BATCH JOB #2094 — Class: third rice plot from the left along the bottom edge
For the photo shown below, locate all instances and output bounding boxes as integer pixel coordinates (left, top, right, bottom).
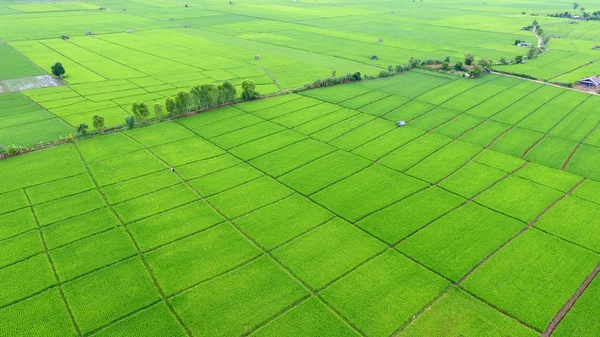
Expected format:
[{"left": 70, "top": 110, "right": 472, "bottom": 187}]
[{"left": 172, "top": 256, "right": 308, "bottom": 336}]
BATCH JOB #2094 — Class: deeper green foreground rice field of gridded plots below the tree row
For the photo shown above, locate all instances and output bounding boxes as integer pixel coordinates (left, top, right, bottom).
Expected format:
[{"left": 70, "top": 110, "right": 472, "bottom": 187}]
[{"left": 0, "top": 70, "right": 600, "bottom": 336}]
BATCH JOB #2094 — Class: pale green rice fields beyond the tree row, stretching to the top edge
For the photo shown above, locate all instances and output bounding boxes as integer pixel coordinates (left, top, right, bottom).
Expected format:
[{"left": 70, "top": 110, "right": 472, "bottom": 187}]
[{"left": 0, "top": 0, "right": 600, "bottom": 146}]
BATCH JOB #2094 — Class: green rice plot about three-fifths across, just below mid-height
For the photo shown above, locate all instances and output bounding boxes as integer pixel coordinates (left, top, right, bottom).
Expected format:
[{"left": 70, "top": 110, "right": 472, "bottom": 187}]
[{"left": 311, "top": 165, "right": 427, "bottom": 222}]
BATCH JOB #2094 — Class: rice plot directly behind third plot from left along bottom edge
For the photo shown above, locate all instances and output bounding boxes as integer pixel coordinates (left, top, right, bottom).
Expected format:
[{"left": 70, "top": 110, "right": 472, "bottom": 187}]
[{"left": 146, "top": 223, "right": 260, "bottom": 296}]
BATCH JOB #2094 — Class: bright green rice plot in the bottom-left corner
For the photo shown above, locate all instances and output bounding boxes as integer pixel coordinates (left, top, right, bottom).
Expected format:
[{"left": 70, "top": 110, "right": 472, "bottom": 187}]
[{"left": 0, "top": 288, "right": 77, "bottom": 337}]
